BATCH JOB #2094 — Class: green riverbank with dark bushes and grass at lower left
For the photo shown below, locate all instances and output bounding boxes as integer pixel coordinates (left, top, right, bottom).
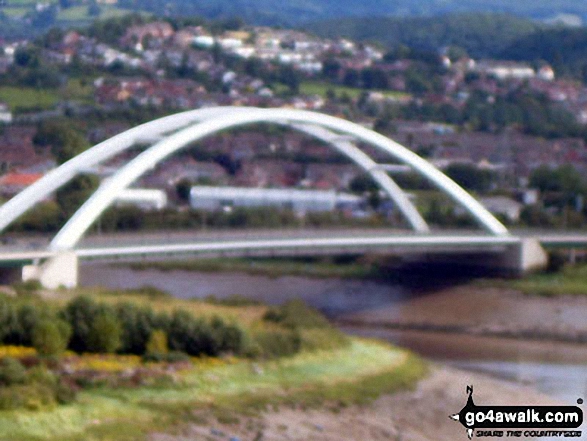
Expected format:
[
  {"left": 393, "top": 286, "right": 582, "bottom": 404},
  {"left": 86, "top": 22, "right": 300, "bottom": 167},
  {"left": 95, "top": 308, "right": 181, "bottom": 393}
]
[{"left": 0, "top": 286, "right": 426, "bottom": 440}]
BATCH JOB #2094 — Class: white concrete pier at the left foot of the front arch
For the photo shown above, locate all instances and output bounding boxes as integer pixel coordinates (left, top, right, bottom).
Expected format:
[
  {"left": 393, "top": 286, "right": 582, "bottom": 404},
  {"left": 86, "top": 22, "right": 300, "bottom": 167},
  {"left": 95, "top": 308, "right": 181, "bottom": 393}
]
[{"left": 22, "top": 251, "right": 78, "bottom": 289}]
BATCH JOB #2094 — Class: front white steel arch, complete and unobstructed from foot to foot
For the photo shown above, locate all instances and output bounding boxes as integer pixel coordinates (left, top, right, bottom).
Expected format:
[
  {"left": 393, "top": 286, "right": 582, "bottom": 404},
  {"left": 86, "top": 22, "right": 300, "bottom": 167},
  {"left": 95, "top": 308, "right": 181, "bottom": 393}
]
[{"left": 50, "top": 109, "right": 508, "bottom": 250}]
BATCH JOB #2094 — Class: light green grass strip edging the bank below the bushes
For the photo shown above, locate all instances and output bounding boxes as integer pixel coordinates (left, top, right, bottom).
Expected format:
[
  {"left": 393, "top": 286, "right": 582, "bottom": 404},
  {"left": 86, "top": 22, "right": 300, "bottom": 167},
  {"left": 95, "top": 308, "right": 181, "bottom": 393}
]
[{"left": 0, "top": 339, "right": 426, "bottom": 441}]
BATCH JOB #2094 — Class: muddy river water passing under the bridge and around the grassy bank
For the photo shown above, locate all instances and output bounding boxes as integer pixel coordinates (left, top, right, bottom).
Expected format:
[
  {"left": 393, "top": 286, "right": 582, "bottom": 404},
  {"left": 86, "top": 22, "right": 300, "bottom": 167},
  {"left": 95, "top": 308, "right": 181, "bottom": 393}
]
[{"left": 80, "top": 264, "right": 587, "bottom": 410}]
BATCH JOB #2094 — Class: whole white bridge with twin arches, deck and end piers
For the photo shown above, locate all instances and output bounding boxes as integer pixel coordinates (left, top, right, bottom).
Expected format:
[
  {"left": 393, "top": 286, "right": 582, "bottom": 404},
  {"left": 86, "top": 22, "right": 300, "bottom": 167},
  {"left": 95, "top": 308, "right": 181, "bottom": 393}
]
[{"left": 0, "top": 107, "right": 544, "bottom": 287}]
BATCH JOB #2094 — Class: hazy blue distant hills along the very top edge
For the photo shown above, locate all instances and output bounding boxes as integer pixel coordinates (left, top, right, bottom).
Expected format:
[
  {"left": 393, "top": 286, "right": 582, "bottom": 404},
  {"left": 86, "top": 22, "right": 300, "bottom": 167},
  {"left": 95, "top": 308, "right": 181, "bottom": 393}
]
[{"left": 0, "top": 0, "right": 587, "bottom": 40}]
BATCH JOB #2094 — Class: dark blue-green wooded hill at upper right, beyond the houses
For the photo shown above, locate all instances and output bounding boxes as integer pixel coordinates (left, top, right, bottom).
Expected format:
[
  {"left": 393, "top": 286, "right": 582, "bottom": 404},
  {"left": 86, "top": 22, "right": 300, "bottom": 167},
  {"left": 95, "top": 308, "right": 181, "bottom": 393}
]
[{"left": 304, "top": 14, "right": 587, "bottom": 81}]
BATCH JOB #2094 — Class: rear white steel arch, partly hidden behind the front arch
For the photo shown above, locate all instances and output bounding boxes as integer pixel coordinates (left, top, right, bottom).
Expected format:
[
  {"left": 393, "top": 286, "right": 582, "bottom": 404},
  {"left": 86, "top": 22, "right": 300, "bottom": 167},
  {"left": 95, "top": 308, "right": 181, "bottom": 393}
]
[{"left": 0, "top": 106, "right": 429, "bottom": 232}]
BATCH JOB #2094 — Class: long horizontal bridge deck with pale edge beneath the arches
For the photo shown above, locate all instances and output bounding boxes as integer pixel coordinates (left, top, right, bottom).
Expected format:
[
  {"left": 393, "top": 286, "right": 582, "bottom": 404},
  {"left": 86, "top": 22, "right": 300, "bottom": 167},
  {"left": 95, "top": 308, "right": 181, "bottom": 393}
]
[{"left": 0, "top": 229, "right": 587, "bottom": 264}]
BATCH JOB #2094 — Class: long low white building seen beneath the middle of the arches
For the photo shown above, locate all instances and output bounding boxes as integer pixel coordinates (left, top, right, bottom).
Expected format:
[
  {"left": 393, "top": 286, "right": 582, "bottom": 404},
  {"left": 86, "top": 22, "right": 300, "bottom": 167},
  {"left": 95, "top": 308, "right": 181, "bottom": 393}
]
[{"left": 190, "top": 186, "right": 363, "bottom": 212}]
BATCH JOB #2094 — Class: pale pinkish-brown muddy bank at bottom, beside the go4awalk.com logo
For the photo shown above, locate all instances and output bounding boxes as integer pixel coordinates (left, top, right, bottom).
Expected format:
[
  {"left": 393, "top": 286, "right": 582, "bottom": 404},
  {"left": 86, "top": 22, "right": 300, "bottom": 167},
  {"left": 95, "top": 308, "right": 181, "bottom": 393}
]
[{"left": 150, "top": 365, "right": 568, "bottom": 441}]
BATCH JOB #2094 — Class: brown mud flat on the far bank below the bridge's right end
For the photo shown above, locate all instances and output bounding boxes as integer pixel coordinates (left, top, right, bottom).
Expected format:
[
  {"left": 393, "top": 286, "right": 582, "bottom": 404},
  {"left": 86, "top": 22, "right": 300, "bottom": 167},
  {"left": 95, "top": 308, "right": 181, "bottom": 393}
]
[{"left": 336, "top": 285, "right": 587, "bottom": 343}]
